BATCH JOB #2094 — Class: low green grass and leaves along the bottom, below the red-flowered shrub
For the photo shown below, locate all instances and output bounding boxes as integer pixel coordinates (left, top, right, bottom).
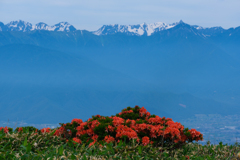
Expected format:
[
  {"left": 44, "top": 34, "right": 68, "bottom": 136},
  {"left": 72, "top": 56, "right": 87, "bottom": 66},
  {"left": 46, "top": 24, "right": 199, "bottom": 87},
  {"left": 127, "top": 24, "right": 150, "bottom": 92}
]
[{"left": 0, "top": 127, "right": 240, "bottom": 160}]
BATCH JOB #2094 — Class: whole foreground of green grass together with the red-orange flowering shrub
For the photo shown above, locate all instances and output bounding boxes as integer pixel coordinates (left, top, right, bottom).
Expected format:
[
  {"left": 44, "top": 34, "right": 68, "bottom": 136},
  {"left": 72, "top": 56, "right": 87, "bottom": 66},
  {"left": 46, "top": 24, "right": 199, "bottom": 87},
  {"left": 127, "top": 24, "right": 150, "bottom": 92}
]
[{"left": 0, "top": 106, "right": 240, "bottom": 160}]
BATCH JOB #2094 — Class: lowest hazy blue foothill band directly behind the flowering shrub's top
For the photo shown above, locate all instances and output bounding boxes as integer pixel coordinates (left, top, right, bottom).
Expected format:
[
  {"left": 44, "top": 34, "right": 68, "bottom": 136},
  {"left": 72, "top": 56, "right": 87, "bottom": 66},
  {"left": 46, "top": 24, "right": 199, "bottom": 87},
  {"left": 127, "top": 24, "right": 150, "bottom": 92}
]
[{"left": 0, "top": 85, "right": 239, "bottom": 124}]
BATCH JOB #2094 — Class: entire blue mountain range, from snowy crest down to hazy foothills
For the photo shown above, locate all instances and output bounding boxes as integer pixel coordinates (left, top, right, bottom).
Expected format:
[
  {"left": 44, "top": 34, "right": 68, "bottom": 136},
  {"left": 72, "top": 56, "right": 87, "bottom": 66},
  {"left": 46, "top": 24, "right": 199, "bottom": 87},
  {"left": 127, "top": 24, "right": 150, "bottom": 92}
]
[{"left": 0, "top": 21, "right": 240, "bottom": 123}]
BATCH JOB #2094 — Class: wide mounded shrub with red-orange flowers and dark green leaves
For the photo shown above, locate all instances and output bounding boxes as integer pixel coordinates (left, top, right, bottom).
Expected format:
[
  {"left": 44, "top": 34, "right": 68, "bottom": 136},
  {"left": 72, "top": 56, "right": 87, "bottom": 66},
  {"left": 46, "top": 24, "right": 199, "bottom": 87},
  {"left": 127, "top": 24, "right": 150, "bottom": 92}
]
[{"left": 54, "top": 106, "right": 203, "bottom": 147}]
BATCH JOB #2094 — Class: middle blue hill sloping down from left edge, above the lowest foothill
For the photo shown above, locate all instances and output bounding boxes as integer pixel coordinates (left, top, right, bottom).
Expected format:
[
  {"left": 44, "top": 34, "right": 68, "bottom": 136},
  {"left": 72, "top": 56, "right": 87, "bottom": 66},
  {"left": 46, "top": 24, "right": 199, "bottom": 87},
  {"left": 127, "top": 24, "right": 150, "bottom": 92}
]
[{"left": 0, "top": 44, "right": 150, "bottom": 89}]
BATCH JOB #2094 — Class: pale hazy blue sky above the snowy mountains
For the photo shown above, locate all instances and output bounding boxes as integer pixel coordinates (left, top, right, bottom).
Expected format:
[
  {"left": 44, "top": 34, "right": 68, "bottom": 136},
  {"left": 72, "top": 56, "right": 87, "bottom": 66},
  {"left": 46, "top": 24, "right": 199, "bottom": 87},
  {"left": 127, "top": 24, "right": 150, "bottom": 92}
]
[{"left": 0, "top": 0, "right": 240, "bottom": 31}]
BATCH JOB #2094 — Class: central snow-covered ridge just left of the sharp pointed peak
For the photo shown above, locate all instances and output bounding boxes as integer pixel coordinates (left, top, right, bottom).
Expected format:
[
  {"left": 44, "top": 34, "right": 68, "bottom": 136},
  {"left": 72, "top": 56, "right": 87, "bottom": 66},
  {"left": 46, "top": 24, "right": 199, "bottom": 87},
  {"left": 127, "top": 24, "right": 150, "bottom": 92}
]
[{"left": 93, "top": 22, "right": 178, "bottom": 36}]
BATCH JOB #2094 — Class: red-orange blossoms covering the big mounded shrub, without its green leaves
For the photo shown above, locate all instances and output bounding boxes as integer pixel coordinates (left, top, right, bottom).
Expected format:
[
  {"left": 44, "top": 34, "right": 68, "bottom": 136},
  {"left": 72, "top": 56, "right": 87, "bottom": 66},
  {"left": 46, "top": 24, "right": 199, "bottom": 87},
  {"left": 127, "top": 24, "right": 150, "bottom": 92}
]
[{"left": 54, "top": 107, "right": 203, "bottom": 146}]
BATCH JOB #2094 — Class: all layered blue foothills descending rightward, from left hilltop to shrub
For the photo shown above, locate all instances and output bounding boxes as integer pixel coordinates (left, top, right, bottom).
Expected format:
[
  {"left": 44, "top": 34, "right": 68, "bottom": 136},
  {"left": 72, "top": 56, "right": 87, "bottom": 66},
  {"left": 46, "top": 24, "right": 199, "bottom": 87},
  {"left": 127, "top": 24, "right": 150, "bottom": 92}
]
[{"left": 0, "top": 44, "right": 237, "bottom": 123}]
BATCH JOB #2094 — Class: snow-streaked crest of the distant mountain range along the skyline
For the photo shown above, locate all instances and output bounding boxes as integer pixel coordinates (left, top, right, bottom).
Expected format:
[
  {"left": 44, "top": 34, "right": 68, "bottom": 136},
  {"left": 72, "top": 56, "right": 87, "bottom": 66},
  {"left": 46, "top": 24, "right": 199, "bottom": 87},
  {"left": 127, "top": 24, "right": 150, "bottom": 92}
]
[{"left": 0, "top": 20, "right": 235, "bottom": 37}]
